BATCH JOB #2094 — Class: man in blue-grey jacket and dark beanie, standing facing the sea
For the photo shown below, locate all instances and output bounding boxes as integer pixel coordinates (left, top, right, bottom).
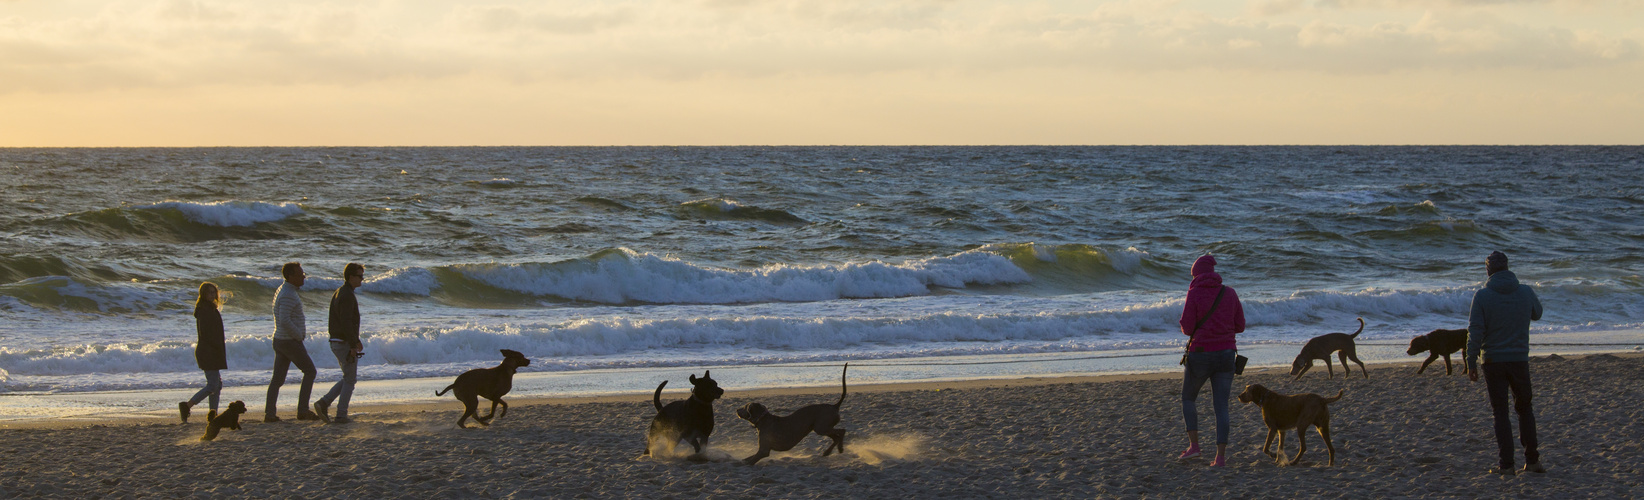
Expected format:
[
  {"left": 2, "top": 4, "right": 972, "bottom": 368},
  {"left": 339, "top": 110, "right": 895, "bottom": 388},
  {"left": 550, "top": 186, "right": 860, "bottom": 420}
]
[{"left": 1466, "top": 252, "right": 1547, "bottom": 475}]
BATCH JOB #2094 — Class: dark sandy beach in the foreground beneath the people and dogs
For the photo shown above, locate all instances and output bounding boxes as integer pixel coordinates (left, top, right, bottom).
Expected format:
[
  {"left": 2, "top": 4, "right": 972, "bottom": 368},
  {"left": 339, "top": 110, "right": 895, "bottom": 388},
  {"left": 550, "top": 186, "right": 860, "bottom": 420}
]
[{"left": 0, "top": 355, "right": 1644, "bottom": 498}]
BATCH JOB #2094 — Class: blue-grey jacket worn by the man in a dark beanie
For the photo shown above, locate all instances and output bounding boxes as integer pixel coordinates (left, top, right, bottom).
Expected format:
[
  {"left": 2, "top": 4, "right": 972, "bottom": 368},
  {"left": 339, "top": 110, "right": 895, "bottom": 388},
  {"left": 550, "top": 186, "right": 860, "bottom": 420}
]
[{"left": 1466, "top": 270, "right": 1542, "bottom": 370}]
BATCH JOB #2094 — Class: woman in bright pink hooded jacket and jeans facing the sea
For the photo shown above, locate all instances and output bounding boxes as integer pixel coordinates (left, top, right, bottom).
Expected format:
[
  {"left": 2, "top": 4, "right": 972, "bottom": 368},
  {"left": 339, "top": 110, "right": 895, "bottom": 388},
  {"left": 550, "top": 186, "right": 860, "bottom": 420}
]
[{"left": 1182, "top": 255, "right": 1245, "bottom": 467}]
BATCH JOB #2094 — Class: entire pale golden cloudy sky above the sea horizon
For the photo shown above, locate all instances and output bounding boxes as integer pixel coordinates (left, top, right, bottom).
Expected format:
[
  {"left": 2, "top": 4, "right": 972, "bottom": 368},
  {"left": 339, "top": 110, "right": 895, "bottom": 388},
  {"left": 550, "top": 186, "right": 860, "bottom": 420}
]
[{"left": 0, "top": 0, "right": 1644, "bottom": 146}]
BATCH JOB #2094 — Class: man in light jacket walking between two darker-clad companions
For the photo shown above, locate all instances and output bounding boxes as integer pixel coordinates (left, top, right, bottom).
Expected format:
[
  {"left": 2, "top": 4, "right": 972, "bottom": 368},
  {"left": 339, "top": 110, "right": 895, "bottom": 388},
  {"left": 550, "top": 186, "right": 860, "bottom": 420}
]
[{"left": 263, "top": 262, "right": 319, "bottom": 423}]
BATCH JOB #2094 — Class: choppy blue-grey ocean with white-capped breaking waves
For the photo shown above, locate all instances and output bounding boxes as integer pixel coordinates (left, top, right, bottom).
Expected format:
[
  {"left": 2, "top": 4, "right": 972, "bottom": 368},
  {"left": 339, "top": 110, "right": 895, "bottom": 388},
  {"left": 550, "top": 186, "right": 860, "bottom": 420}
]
[{"left": 0, "top": 146, "right": 1644, "bottom": 398}]
